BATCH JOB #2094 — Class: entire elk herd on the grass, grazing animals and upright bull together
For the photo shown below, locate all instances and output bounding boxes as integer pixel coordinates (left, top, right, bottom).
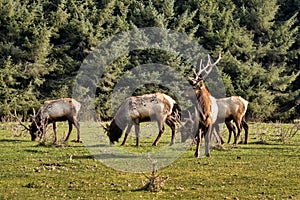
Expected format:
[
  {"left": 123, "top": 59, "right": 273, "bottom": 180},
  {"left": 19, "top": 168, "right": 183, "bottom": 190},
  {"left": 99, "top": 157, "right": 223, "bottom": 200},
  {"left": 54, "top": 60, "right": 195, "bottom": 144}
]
[{"left": 15, "top": 54, "right": 253, "bottom": 158}]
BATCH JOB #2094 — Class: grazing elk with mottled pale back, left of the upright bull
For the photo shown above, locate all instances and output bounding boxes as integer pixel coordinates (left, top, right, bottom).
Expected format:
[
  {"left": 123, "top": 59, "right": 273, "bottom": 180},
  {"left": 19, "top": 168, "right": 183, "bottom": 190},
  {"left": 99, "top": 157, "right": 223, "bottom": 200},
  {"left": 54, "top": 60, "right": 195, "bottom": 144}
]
[{"left": 101, "top": 93, "right": 176, "bottom": 146}]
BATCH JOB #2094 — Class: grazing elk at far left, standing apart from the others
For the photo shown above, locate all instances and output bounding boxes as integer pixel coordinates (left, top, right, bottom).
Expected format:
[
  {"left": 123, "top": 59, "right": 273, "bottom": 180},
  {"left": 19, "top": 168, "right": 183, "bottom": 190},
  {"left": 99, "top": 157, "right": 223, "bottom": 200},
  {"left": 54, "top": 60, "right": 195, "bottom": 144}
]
[{"left": 21, "top": 98, "right": 81, "bottom": 143}]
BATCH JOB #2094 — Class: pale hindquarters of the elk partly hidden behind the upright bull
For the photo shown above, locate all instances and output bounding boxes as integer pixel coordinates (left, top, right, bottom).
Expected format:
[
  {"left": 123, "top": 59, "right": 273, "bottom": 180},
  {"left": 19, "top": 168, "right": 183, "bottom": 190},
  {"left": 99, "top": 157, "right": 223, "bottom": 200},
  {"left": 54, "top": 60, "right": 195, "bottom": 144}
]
[{"left": 215, "top": 96, "right": 249, "bottom": 146}]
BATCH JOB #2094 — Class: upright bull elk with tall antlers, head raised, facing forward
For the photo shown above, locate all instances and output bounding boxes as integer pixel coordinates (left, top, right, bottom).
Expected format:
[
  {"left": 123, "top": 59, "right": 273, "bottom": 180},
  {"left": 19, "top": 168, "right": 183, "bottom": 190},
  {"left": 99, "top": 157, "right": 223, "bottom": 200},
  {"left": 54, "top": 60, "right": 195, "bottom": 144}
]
[{"left": 182, "top": 53, "right": 221, "bottom": 158}]
